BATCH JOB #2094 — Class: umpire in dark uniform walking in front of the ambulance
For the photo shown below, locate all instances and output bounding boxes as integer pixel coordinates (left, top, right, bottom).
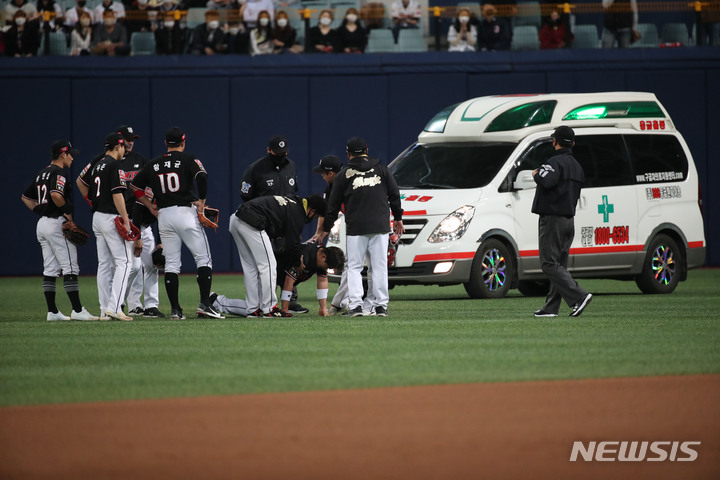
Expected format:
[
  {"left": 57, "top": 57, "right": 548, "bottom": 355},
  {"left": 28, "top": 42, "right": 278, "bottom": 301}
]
[{"left": 532, "top": 125, "right": 592, "bottom": 317}]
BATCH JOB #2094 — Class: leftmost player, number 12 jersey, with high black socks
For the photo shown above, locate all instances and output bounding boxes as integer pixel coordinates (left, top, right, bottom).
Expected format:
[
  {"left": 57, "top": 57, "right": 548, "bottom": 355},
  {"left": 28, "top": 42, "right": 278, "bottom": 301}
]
[{"left": 22, "top": 140, "right": 98, "bottom": 322}]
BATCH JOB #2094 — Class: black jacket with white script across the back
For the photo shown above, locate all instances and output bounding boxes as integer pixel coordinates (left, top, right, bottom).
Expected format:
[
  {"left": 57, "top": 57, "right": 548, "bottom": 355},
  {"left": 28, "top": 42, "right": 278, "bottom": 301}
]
[{"left": 323, "top": 156, "right": 403, "bottom": 235}]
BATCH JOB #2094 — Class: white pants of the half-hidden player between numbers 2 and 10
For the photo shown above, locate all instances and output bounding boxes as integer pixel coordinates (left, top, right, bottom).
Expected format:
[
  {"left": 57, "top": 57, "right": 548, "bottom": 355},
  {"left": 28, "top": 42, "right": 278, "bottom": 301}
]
[{"left": 127, "top": 226, "right": 160, "bottom": 311}]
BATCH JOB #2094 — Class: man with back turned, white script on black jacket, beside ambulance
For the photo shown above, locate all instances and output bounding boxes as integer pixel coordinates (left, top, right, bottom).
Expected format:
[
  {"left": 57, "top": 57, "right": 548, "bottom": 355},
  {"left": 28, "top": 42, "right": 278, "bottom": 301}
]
[{"left": 323, "top": 137, "right": 405, "bottom": 317}]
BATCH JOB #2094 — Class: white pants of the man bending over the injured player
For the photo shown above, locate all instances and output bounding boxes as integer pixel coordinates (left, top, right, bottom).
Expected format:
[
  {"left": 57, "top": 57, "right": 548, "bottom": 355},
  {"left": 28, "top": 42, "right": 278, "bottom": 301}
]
[{"left": 230, "top": 215, "right": 277, "bottom": 313}]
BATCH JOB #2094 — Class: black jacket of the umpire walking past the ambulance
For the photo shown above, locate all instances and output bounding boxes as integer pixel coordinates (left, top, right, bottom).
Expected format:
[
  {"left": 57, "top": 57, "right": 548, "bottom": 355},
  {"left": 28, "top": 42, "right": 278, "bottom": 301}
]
[{"left": 532, "top": 148, "right": 585, "bottom": 217}]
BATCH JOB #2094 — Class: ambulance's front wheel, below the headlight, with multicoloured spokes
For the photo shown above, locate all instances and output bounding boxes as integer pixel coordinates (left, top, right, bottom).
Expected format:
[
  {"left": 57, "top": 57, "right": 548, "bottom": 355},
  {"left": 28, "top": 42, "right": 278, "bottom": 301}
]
[{"left": 463, "top": 238, "right": 517, "bottom": 298}]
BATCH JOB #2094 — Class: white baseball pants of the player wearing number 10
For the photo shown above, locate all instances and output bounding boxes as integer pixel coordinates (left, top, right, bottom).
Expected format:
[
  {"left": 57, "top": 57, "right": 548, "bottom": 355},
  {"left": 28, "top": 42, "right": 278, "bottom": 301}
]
[{"left": 158, "top": 206, "right": 212, "bottom": 273}]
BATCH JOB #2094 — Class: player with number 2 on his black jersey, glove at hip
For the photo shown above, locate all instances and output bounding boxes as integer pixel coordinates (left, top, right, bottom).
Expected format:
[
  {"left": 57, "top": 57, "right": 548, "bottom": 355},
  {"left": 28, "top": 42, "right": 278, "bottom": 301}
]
[{"left": 77, "top": 132, "right": 133, "bottom": 321}]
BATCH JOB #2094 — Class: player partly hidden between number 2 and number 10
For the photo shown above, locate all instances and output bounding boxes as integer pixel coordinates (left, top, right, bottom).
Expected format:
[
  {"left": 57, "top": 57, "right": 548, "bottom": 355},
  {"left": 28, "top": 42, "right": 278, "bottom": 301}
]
[{"left": 115, "top": 125, "right": 165, "bottom": 318}]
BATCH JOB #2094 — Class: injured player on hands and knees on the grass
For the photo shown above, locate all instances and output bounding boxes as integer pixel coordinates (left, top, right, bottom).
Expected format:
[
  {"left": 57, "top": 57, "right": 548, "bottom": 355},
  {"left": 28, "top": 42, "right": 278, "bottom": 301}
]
[{"left": 210, "top": 243, "right": 345, "bottom": 318}]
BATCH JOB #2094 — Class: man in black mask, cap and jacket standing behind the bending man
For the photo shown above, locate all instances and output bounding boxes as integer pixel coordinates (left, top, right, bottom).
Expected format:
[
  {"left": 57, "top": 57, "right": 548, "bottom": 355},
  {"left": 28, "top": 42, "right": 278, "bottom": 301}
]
[{"left": 240, "top": 135, "right": 309, "bottom": 313}]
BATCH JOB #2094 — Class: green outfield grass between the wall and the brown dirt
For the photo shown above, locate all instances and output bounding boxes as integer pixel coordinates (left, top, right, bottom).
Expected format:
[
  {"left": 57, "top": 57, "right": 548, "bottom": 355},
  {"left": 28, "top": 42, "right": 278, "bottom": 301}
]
[{"left": 0, "top": 269, "right": 720, "bottom": 405}]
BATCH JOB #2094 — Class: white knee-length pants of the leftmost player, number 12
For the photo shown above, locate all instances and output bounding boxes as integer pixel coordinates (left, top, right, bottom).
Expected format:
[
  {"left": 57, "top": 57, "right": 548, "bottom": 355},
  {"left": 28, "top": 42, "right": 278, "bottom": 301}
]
[{"left": 35, "top": 217, "right": 80, "bottom": 277}]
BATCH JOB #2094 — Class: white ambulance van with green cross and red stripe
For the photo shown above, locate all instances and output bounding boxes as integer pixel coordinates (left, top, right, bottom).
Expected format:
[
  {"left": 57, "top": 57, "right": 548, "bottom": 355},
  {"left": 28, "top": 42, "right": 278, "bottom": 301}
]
[{"left": 329, "top": 92, "right": 706, "bottom": 298}]
